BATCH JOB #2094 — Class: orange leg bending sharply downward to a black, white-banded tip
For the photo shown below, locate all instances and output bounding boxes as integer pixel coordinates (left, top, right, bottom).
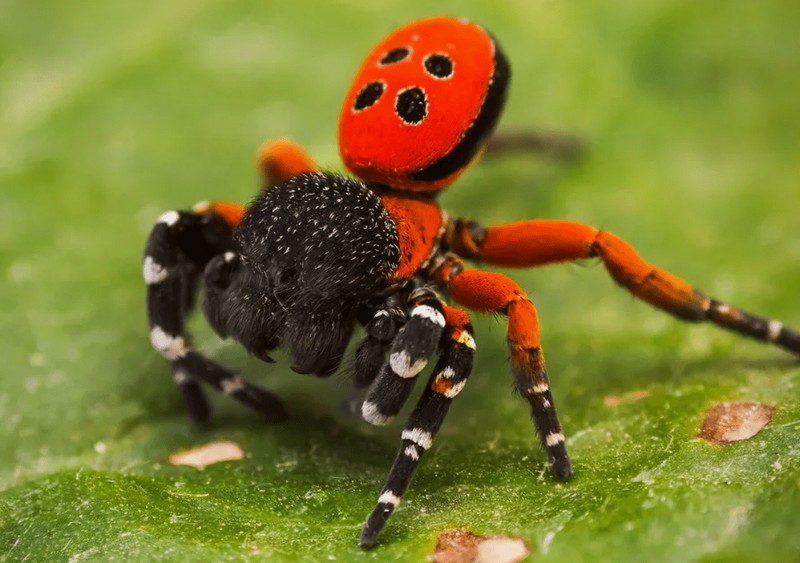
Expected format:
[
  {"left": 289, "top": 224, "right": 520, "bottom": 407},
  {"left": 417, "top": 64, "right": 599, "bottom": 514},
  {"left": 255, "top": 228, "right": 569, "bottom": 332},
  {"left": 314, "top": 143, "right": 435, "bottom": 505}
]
[{"left": 436, "top": 260, "right": 572, "bottom": 481}]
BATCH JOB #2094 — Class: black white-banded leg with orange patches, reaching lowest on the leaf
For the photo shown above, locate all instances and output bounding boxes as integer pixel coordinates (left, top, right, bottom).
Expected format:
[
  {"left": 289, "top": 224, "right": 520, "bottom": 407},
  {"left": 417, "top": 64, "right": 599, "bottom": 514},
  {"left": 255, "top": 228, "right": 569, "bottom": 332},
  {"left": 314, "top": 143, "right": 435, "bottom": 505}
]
[{"left": 360, "top": 305, "right": 475, "bottom": 549}]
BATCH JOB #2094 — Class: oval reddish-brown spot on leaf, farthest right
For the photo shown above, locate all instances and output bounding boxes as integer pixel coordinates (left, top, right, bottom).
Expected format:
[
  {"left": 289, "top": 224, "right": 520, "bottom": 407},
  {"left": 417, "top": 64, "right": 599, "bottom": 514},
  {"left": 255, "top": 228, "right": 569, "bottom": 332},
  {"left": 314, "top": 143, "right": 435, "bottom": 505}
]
[{"left": 698, "top": 401, "right": 775, "bottom": 444}]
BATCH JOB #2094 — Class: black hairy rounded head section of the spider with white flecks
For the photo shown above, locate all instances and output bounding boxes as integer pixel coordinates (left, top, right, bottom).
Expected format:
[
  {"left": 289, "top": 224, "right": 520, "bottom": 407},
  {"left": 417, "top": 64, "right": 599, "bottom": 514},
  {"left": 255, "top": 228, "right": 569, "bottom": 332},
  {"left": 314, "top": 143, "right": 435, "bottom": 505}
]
[{"left": 211, "top": 173, "right": 400, "bottom": 375}]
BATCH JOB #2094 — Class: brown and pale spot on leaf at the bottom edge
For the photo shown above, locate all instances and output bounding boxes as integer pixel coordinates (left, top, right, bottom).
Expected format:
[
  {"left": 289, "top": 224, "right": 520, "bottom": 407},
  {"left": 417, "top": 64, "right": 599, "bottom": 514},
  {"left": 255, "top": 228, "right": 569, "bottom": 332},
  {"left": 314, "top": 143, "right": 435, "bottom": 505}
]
[{"left": 428, "top": 529, "right": 530, "bottom": 563}]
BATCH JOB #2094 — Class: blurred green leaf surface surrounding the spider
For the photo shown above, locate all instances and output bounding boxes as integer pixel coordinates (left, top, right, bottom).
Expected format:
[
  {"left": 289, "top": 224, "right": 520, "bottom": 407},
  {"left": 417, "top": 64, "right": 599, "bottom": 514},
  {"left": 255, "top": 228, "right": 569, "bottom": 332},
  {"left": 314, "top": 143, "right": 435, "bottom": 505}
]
[{"left": 0, "top": 0, "right": 800, "bottom": 561}]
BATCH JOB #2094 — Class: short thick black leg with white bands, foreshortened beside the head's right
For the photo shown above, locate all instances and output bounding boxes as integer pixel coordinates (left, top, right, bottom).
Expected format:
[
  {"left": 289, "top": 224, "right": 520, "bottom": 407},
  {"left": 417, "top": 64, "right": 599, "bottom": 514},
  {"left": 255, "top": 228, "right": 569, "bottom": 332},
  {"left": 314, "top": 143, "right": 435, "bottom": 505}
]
[{"left": 361, "top": 287, "right": 445, "bottom": 424}]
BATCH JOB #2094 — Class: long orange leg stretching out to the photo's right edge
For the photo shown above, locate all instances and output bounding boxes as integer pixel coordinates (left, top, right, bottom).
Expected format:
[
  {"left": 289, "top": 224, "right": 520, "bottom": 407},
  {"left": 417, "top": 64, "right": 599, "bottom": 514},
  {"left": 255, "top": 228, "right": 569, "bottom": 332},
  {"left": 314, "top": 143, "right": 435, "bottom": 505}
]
[{"left": 450, "top": 220, "right": 800, "bottom": 355}]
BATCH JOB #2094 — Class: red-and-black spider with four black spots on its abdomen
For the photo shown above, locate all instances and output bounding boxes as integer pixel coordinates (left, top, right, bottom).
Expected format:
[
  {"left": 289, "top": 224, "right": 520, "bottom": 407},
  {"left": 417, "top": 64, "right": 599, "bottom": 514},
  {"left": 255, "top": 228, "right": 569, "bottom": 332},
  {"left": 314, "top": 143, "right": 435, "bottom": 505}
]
[{"left": 144, "top": 17, "right": 800, "bottom": 548}]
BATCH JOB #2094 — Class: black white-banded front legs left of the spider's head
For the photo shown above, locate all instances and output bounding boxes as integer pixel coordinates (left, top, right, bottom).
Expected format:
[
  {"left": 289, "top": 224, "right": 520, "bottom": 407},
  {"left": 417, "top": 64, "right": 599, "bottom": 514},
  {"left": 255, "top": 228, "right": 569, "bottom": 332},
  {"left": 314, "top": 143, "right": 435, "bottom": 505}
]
[{"left": 143, "top": 211, "right": 283, "bottom": 422}]
